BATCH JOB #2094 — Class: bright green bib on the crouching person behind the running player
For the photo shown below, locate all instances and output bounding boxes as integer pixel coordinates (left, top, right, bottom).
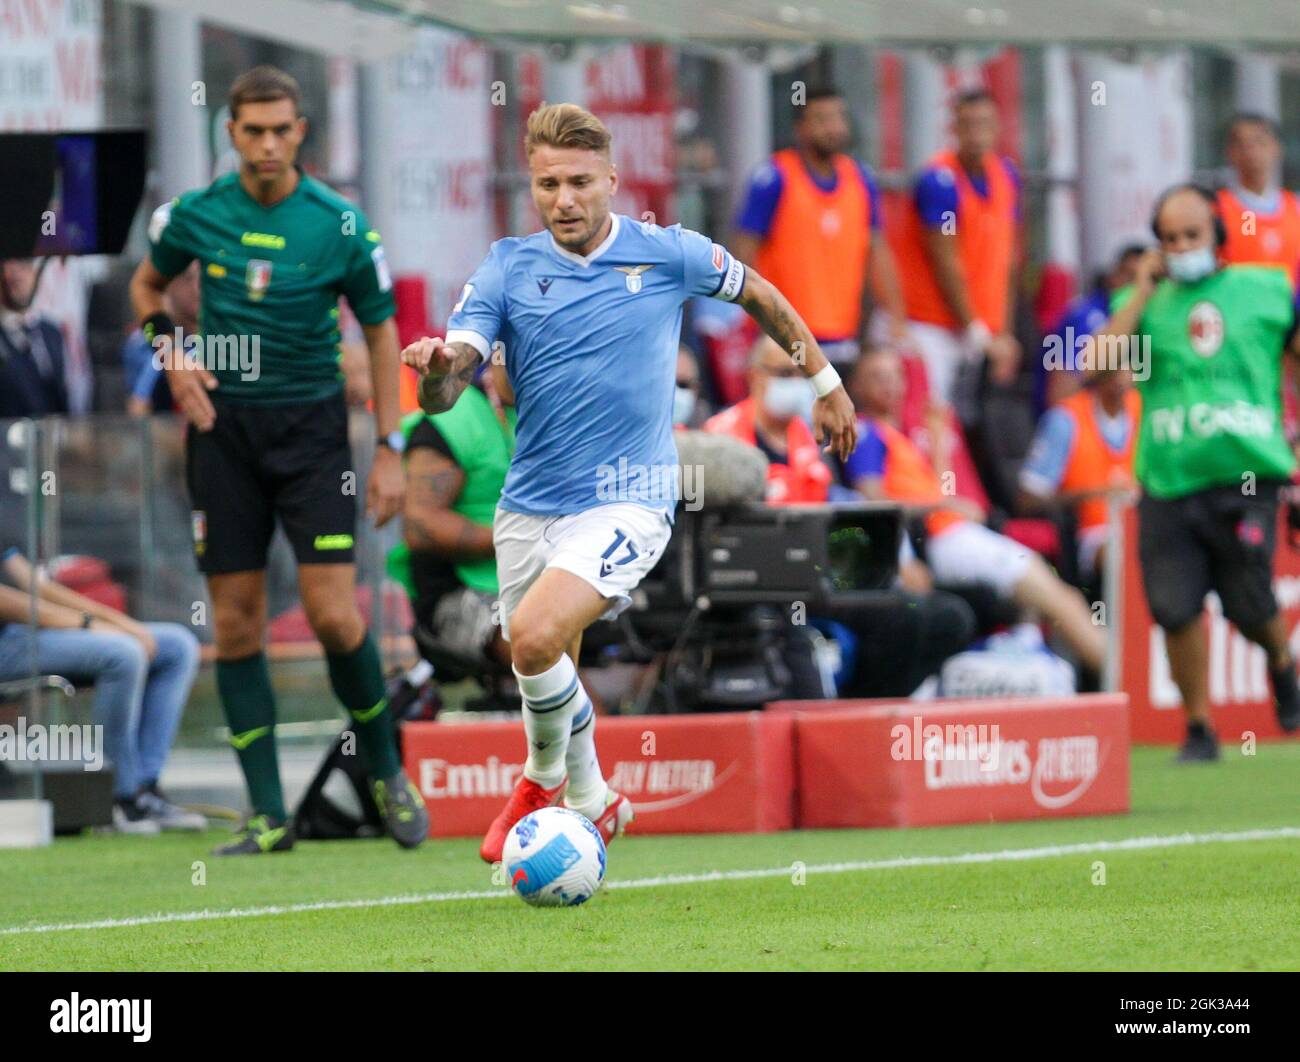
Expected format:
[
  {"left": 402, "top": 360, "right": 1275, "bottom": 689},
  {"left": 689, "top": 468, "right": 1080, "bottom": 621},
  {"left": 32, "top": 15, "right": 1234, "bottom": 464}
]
[{"left": 387, "top": 387, "right": 515, "bottom": 601}]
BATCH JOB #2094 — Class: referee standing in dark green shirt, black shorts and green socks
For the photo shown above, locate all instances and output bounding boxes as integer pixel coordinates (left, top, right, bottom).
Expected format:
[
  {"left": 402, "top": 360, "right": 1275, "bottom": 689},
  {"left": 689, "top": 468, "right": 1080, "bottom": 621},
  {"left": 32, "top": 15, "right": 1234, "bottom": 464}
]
[{"left": 131, "top": 66, "right": 429, "bottom": 855}]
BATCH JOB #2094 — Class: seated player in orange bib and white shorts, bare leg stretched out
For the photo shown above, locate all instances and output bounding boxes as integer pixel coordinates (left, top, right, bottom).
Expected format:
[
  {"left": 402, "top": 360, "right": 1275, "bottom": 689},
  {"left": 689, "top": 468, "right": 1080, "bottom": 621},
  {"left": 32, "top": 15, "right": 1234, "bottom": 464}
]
[{"left": 845, "top": 348, "right": 1105, "bottom": 671}]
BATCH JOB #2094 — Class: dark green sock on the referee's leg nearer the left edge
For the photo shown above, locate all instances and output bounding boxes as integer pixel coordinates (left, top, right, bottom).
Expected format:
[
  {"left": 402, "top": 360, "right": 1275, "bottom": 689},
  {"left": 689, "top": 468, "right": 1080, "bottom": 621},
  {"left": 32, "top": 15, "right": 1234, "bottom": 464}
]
[{"left": 217, "top": 653, "right": 289, "bottom": 822}]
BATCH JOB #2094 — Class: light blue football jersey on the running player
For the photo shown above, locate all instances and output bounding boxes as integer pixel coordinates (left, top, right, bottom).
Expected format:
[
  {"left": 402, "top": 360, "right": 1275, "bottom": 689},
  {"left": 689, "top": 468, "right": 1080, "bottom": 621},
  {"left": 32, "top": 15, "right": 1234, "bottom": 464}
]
[{"left": 447, "top": 214, "right": 745, "bottom": 516}]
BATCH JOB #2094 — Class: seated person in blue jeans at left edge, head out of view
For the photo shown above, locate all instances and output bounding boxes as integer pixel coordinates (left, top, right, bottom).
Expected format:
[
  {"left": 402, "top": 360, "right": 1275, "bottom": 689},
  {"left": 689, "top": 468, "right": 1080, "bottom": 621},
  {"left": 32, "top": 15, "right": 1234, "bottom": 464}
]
[{"left": 0, "top": 546, "right": 207, "bottom": 833}]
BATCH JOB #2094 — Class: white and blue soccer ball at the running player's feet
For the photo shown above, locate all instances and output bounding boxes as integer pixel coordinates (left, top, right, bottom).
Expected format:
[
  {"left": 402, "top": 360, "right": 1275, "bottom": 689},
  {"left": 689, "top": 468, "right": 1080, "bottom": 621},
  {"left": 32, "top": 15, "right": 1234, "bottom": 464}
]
[{"left": 501, "top": 807, "right": 605, "bottom": 907}]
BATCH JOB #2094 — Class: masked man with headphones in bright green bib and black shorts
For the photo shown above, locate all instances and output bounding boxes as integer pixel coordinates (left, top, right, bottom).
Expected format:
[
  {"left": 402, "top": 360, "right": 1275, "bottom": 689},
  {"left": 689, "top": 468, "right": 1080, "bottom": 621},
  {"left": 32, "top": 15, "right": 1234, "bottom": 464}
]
[{"left": 1101, "top": 185, "right": 1300, "bottom": 762}]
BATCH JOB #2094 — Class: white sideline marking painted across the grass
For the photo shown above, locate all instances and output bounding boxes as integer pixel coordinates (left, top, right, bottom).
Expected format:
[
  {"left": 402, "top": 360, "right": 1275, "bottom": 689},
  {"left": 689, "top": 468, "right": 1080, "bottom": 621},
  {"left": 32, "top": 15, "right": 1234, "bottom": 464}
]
[{"left": 0, "top": 825, "right": 1300, "bottom": 936}]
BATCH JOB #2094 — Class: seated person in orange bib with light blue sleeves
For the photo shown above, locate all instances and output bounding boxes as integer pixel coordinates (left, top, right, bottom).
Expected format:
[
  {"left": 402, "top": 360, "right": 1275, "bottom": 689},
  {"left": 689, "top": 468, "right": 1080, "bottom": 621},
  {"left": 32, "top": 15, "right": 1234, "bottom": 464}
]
[{"left": 1021, "top": 369, "right": 1141, "bottom": 588}]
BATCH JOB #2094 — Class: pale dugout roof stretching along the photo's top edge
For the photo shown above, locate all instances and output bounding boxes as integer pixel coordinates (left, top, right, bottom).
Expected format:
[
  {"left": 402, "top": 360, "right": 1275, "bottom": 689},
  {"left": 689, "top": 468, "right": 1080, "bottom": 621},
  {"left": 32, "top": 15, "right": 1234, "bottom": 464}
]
[{"left": 129, "top": 0, "right": 1300, "bottom": 60}]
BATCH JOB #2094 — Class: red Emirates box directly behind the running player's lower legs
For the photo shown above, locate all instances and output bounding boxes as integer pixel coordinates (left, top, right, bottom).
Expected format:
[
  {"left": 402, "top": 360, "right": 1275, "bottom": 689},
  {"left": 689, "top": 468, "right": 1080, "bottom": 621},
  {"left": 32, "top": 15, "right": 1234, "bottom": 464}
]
[{"left": 402, "top": 712, "right": 794, "bottom": 837}]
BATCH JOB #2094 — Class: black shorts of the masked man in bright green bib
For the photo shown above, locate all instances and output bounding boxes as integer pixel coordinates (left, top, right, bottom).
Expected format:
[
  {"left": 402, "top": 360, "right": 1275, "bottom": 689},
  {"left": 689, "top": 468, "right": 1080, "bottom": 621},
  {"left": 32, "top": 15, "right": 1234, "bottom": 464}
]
[{"left": 1138, "top": 480, "right": 1282, "bottom": 632}]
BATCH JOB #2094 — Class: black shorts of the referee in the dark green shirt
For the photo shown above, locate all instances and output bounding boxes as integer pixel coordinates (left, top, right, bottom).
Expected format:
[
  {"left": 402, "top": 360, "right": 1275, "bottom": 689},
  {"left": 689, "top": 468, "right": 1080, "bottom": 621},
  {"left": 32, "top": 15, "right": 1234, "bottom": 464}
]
[{"left": 186, "top": 394, "right": 358, "bottom": 575}]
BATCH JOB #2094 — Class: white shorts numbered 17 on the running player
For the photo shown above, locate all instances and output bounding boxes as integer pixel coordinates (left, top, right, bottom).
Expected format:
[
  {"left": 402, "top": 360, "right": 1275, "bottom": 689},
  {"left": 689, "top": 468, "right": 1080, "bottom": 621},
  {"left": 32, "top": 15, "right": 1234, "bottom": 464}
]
[{"left": 491, "top": 502, "right": 672, "bottom": 641}]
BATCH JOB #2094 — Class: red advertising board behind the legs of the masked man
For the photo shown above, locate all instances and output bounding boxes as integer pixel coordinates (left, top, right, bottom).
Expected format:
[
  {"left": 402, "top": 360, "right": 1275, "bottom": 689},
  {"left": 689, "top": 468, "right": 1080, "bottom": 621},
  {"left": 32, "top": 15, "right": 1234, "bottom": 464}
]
[{"left": 1119, "top": 510, "right": 1300, "bottom": 744}]
